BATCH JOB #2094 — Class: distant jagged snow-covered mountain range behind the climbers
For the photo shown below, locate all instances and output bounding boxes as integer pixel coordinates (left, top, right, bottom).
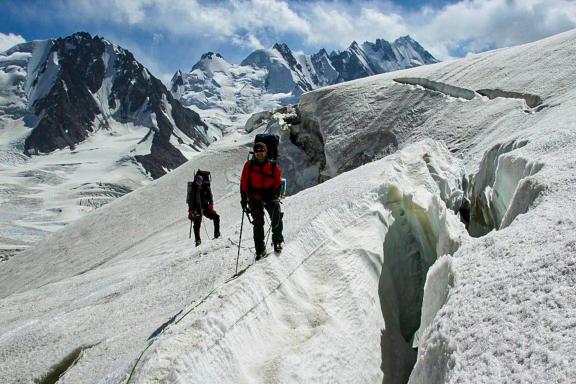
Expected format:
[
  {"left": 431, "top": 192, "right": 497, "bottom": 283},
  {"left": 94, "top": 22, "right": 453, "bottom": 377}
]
[{"left": 171, "top": 36, "right": 437, "bottom": 125}]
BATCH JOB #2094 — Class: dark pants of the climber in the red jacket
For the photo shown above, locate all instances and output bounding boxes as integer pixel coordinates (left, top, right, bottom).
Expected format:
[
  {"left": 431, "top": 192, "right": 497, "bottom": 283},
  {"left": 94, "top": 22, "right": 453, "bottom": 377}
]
[{"left": 248, "top": 198, "right": 284, "bottom": 254}]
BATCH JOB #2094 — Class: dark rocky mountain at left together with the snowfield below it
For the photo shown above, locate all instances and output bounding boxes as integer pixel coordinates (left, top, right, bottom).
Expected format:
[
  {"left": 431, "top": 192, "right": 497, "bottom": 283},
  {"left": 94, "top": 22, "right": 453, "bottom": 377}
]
[{"left": 0, "top": 33, "right": 214, "bottom": 256}]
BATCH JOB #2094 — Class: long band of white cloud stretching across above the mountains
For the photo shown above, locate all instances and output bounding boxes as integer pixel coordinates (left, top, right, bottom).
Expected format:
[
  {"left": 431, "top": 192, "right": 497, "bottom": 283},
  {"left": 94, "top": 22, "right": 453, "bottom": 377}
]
[{"left": 12, "top": 0, "right": 576, "bottom": 59}]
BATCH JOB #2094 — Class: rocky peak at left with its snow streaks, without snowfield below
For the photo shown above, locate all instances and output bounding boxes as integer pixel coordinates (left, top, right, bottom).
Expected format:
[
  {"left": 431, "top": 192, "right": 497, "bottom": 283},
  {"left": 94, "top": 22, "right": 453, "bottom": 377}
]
[{"left": 0, "top": 32, "right": 214, "bottom": 178}]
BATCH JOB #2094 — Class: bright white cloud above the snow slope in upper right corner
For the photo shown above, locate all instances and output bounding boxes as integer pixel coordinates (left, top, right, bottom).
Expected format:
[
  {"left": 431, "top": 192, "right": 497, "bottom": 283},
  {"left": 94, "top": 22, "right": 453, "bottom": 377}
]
[{"left": 411, "top": 0, "right": 576, "bottom": 58}]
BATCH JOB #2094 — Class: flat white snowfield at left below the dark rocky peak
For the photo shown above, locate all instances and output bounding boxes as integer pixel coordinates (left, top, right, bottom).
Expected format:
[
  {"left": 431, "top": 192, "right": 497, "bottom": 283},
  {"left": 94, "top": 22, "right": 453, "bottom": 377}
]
[{"left": 0, "top": 117, "right": 155, "bottom": 255}]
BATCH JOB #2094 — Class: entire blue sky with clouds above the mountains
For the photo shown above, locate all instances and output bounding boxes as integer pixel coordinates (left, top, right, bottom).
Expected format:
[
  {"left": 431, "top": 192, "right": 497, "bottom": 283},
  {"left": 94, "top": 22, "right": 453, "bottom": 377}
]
[{"left": 0, "top": 0, "right": 576, "bottom": 81}]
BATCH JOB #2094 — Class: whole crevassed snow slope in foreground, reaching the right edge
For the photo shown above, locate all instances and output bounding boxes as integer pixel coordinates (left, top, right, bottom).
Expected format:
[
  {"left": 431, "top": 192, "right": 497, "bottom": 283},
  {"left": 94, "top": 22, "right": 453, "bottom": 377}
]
[{"left": 0, "top": 27, "right": 576, "bottom": 383}]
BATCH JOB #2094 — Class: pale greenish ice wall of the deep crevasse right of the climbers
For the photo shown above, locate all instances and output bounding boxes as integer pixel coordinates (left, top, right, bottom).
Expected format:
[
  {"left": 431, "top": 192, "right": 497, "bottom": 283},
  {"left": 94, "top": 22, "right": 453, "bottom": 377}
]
[{"left": 378, "top": 141, "right": 466, "bottom": 384}]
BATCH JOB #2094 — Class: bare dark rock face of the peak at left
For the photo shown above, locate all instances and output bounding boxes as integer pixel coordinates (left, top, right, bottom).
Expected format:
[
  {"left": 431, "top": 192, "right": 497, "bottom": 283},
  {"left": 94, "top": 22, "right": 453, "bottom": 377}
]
[{"left": 25, "top": 33, "right": 209, "bottom": 178}]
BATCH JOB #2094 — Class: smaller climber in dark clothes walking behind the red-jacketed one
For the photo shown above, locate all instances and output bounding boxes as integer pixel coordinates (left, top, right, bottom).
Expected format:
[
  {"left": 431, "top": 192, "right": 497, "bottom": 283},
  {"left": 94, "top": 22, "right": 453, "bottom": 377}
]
[{"left": 187, "top": 175, "right": 220, "bottom": 246}]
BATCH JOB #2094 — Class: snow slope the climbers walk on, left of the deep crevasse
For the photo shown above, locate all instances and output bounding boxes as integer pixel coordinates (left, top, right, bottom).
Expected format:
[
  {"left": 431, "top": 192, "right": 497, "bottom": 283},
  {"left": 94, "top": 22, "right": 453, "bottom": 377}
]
[{"left": 1, "top": 133, "right": 458, "bottom": 383}]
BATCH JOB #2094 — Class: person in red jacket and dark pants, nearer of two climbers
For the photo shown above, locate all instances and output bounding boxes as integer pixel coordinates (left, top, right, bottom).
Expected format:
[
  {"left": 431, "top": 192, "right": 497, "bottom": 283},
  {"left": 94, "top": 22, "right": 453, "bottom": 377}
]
[{"left": 240, "top": 143, "right": 284, "bottom": 260}]
